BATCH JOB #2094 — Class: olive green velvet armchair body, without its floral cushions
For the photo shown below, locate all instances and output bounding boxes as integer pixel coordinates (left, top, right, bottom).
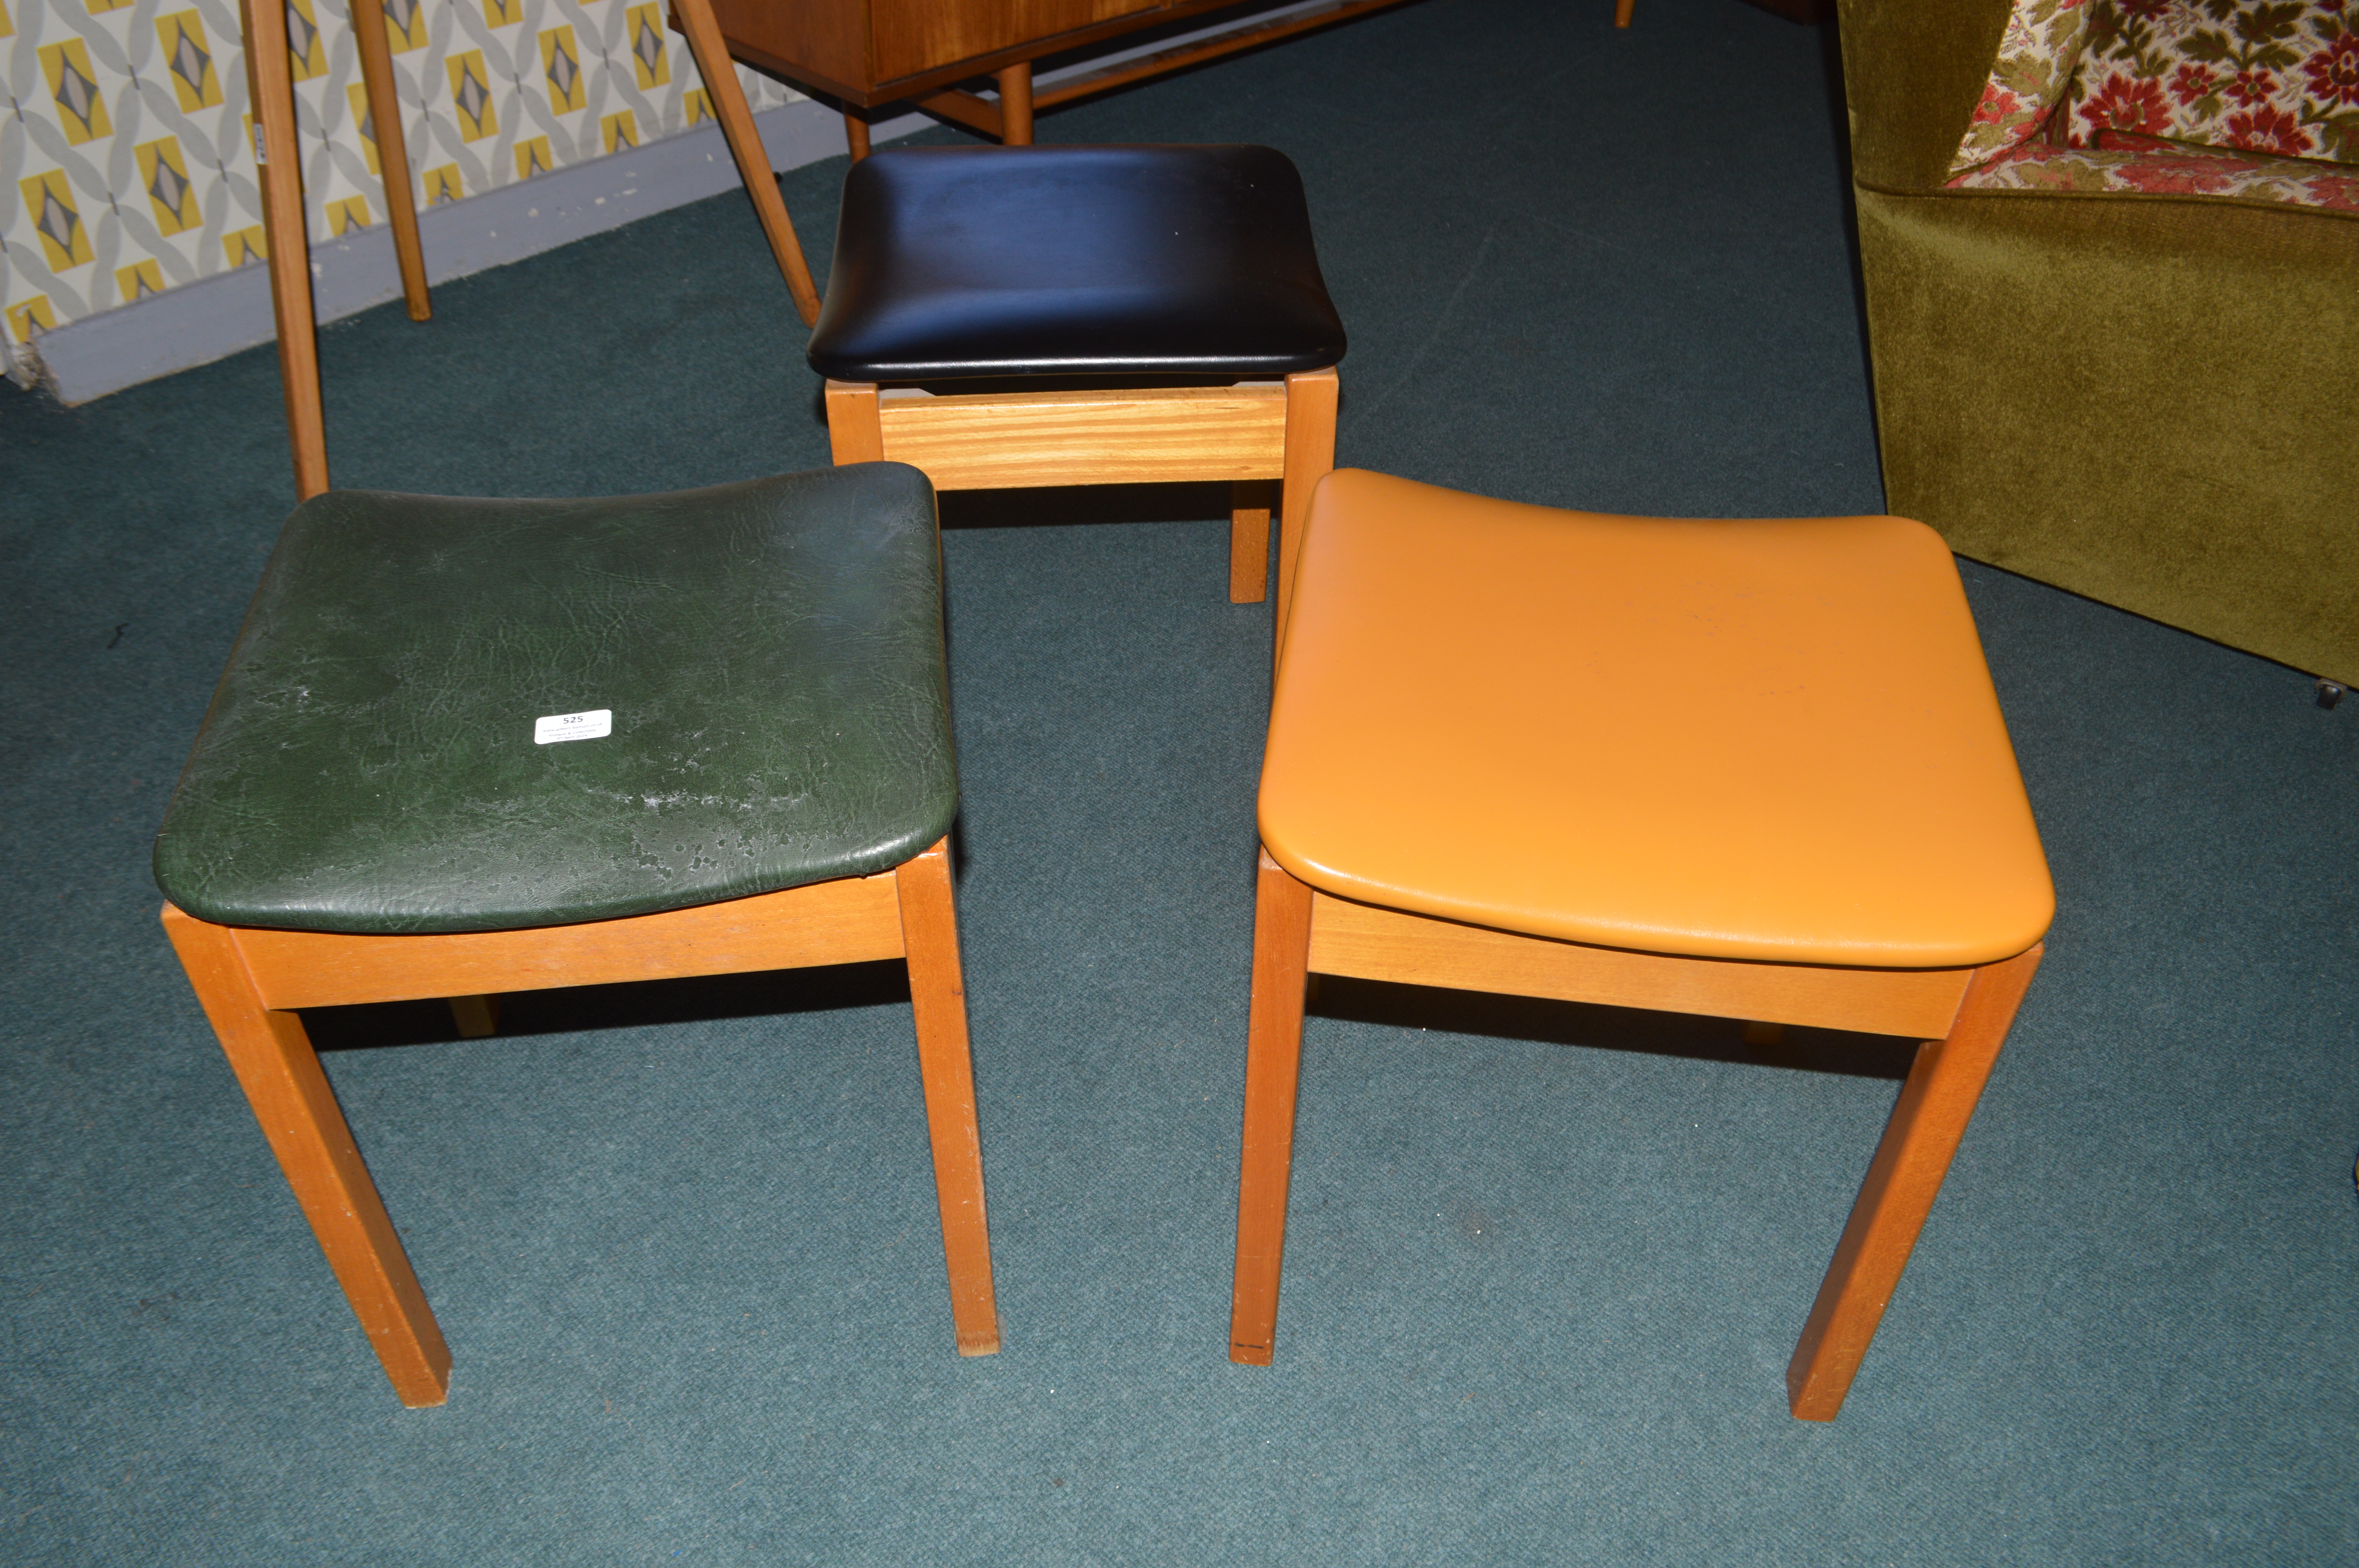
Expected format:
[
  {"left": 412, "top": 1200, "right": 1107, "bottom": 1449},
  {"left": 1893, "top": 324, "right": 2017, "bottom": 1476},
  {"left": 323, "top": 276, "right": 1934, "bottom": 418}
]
[{"left": 1840, "top": 0, "right": 2359, "bottom": 681}]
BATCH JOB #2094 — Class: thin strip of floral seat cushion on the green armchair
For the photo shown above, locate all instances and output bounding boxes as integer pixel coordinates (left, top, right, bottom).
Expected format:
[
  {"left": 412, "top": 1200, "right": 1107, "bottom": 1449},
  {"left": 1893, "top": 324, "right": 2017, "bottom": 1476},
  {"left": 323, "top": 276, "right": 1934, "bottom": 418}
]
[{"left": 1948, "top": 130, "right": 2359, "bottom": 214}]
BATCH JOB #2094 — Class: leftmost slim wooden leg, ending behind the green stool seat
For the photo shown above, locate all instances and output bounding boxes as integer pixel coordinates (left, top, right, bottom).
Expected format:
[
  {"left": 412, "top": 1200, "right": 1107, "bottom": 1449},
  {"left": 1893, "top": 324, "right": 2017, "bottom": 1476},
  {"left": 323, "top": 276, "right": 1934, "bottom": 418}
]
[{"left": 238, "top": 0, "right": 328, "bottom": 500}]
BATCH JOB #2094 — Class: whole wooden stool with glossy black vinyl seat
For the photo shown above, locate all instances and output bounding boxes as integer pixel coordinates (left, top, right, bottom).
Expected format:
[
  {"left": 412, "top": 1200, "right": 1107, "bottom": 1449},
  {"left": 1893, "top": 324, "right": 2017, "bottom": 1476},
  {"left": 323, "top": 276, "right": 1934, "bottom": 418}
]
[{"left": 812, "top": 146, "right": 1345, "bottom": 620}]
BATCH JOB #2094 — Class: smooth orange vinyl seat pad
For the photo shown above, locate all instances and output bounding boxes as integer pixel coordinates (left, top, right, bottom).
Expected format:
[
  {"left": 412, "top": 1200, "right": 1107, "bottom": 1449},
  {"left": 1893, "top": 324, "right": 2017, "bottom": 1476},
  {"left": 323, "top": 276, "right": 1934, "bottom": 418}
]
[{"left": 1260, "top": 469, "right": 2055, "bottom": 969}]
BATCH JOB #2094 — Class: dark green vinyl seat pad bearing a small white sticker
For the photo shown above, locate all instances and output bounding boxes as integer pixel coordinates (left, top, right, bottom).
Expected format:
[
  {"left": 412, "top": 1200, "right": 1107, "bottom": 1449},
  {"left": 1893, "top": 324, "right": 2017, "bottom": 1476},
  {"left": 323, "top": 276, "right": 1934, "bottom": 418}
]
[{"left": 156, "top": 462, "right": 958, "bottom": 934}]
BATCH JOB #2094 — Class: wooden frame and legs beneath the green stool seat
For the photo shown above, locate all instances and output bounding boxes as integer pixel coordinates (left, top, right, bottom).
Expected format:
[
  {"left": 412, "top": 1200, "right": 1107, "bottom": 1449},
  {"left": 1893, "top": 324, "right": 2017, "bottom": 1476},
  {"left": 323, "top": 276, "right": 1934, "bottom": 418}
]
[{"left": 163, "top": 839, "right": 1000, "bottom": 1408}]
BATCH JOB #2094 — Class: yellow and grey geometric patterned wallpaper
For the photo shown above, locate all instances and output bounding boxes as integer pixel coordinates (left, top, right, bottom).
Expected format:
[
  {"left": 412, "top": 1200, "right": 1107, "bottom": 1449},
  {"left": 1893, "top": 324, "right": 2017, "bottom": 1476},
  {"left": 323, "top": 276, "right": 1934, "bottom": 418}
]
[{"left": 0, "top": 0, "right": 800, "bottom": 342}]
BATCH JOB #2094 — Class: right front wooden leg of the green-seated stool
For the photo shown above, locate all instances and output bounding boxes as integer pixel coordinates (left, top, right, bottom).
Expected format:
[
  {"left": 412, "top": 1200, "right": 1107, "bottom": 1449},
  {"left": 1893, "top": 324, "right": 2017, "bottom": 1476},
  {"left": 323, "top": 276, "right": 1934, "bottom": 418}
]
[{"left": 894, "top": 839, "right": 1000, "bottom": 1356}]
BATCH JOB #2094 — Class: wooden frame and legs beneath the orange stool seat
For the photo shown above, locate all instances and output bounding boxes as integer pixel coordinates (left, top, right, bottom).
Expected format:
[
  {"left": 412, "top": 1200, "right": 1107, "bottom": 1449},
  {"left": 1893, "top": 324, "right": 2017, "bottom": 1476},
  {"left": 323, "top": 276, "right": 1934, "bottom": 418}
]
[{"left": 1229, "top": 849, "right": 2043, "bottom": 1422}]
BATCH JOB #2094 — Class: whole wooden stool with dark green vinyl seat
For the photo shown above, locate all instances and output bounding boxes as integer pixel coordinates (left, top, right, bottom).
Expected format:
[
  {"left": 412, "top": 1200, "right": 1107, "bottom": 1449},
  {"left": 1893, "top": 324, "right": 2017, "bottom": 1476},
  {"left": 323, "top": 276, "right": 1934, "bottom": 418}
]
[{"left": 156, "top": 462, "right": 1000, "bottom": 1405}]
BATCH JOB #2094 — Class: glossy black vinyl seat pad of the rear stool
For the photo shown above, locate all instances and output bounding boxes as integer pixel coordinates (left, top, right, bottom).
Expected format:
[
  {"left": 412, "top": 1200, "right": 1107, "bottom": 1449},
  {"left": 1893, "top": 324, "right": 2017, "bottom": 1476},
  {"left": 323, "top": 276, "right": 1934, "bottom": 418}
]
[{"left": 809, "top": 146, "right": 1345, "bottom": 382}]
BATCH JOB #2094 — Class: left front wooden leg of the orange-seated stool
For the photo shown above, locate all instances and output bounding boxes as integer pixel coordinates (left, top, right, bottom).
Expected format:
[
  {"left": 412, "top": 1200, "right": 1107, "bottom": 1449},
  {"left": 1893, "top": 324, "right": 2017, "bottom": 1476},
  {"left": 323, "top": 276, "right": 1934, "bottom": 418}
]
[{"left": 1229, "top": 849, "right": 1312, "bottom": 1368}]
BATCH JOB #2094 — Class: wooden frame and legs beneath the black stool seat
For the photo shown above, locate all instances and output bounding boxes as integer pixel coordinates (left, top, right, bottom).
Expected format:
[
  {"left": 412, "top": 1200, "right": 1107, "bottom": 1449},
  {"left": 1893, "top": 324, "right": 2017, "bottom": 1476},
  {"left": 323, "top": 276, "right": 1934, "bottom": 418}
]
[{"left": 828, "top": 368, "right": 1340, "bottom": 630}]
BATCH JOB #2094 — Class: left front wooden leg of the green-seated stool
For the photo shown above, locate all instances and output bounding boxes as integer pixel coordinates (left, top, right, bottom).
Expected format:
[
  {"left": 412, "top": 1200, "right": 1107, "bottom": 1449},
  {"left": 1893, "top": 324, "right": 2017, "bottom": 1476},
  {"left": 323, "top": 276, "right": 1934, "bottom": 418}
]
[{"left": 163, "top": 906, "right": 451, "bottom": 1408}]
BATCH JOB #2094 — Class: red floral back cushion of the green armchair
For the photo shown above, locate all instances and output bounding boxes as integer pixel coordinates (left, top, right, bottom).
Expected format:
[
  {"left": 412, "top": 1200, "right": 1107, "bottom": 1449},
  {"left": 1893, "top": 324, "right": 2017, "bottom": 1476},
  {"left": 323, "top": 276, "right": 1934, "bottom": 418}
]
[{"left": 2066, "top": 0, "right": 2359, "bottom": 163}]
